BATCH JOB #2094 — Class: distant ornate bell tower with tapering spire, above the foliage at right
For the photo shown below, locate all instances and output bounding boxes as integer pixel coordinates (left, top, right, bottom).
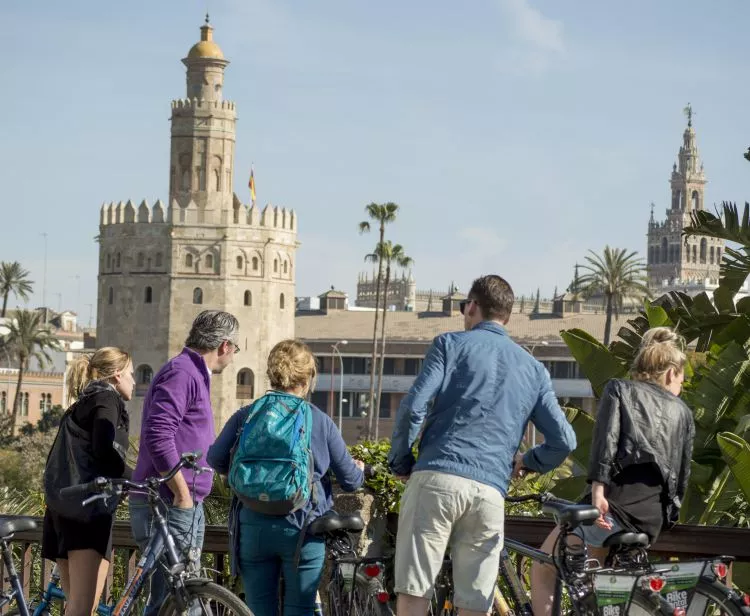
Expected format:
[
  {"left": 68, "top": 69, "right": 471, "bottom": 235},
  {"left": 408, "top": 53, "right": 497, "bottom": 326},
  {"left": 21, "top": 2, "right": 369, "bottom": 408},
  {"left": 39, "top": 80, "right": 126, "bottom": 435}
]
[{"left": 648, "top": 105, "right": 724, "bottom": 295}]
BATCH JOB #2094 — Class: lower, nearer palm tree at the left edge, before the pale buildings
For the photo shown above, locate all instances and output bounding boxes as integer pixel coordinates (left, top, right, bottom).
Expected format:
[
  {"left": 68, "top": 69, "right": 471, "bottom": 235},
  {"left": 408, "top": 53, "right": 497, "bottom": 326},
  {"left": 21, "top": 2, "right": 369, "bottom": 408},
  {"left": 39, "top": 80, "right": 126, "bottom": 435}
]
[{"left": 5, "top": 310, "right": 62, "bottom": 437}]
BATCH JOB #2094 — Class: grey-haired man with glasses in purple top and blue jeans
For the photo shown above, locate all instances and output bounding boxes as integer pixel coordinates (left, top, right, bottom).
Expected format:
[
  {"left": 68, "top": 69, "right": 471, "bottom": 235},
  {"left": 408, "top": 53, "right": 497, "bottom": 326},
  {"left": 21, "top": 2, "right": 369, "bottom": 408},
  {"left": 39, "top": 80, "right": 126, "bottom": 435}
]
[{"left": 130, "top": 310, "right": 239, "bottom": 616}]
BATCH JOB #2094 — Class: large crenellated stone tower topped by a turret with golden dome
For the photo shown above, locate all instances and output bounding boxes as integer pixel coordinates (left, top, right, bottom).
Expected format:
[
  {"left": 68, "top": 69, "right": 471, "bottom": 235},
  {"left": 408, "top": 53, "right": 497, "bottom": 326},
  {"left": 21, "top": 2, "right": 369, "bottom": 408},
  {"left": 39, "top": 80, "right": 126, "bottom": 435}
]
[{"left": 97, "top": 19, "right": 297, "bottom": 434}]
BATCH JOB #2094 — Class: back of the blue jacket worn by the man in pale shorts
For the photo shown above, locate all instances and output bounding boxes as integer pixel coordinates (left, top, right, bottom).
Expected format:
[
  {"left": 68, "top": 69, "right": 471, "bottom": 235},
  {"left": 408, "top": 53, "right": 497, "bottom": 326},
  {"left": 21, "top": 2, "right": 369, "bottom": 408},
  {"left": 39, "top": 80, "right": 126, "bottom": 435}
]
[{"left": 413, "top": 321, "right": 570, "bottom": 494}]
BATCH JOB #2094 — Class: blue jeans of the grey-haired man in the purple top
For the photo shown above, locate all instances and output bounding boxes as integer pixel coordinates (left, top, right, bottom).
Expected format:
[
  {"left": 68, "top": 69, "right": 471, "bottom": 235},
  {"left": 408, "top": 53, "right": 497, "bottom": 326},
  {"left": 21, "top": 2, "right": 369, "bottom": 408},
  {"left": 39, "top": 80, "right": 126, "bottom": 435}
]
[{"left": 130, "top": 500, "right": 206, "bottom": 616}]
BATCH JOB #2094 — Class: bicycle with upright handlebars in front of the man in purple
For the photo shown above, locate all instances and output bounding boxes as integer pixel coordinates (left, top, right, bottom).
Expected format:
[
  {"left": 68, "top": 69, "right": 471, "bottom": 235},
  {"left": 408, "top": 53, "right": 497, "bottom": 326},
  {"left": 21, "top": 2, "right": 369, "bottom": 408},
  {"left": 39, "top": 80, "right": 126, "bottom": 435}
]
[{"left": 57, "top": 452, "right": 253, "bottom": 616}]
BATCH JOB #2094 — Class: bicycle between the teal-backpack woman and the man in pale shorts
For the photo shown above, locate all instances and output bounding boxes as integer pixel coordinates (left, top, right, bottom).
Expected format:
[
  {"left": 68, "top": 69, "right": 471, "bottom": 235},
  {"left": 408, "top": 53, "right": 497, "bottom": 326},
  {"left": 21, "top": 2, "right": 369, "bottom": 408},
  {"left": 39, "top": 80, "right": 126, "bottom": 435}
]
[{"left": 307, "top": 511, "right": 394, "bottom": 616}]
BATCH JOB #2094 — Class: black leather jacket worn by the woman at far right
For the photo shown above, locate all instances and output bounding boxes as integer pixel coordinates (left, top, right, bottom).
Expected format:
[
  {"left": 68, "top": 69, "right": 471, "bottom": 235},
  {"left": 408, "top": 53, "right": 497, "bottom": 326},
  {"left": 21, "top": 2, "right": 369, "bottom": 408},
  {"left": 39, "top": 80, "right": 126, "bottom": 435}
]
[{"left": 588, "top": 379, "right": 695, "bottom": 526}]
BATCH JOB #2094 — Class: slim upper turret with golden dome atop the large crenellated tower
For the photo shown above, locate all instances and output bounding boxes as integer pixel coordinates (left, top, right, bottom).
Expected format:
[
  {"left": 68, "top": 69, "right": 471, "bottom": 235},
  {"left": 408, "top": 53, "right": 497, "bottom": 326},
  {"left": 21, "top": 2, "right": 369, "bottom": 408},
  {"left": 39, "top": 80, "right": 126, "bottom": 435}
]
[{"left": 169, "top": 15, "right": 237, "bottom": 213}]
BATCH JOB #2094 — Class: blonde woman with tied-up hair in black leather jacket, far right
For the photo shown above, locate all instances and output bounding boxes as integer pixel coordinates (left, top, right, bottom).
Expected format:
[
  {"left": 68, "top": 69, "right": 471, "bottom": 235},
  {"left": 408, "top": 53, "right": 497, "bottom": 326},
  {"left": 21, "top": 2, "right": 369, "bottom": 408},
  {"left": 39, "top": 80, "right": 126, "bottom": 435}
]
[{"left": 531, "top": 327, "right": 695, "bottom": 614}]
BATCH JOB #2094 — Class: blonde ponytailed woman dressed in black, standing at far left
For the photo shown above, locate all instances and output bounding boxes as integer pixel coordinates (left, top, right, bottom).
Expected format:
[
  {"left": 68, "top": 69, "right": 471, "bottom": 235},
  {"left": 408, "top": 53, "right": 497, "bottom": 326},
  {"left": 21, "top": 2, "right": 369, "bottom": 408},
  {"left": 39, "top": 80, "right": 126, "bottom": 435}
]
[{"left": 42, "top": 347, "right": 135, "bottom": 616}]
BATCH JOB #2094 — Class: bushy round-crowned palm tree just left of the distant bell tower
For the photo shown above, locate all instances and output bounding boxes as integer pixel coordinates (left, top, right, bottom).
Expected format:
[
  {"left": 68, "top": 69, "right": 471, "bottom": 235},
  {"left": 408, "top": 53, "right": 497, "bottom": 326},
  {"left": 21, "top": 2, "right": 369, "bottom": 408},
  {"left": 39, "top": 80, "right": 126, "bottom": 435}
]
[{"left": 578, "top": 246, "right": 650, "bottom": 346}]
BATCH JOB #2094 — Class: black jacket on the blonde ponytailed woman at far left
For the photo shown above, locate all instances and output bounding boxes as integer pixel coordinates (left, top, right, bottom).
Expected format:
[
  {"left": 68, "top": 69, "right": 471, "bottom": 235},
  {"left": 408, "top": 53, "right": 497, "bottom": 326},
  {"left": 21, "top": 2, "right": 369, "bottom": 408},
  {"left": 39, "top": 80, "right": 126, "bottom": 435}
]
[{"left": 71, "top": 381, "right": 132, "bottom": 477}]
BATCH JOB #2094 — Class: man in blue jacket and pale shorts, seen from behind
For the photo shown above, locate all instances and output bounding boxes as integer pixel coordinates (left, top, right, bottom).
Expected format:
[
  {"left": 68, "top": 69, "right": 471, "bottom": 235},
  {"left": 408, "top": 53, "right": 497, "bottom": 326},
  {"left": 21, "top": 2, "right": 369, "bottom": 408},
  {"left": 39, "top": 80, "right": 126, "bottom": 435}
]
[{"left": 389, "top": 275, "right": 576, "bottom": 616}]
